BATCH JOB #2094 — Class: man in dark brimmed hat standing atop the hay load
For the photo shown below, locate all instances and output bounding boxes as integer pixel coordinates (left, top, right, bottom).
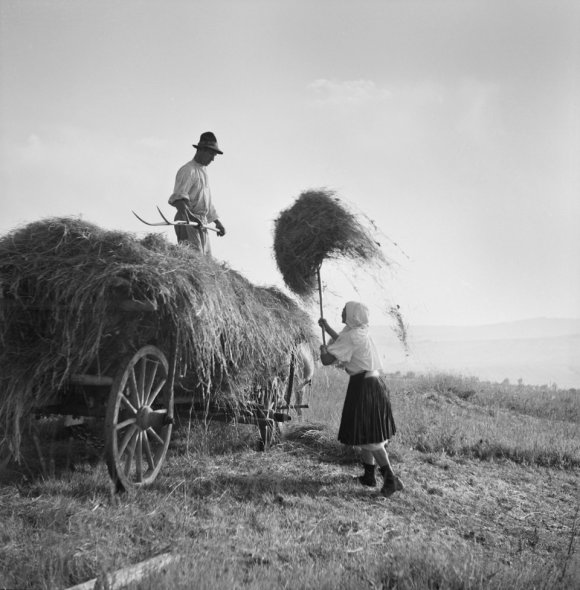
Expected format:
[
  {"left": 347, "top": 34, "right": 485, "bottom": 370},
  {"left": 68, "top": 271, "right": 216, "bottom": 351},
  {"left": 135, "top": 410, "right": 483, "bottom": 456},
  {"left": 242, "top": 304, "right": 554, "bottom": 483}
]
[{"left": 169, "top": 131, "right": 226, "bottom": 255}]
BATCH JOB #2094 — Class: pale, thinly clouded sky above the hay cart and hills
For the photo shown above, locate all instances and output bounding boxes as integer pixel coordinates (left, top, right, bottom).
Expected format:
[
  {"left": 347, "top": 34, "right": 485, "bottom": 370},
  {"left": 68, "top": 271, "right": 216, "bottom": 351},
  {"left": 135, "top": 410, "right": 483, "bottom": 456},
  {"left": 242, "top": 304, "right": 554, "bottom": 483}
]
[{"left": 0, "top": 0, "right": 580, "bottom": 325}]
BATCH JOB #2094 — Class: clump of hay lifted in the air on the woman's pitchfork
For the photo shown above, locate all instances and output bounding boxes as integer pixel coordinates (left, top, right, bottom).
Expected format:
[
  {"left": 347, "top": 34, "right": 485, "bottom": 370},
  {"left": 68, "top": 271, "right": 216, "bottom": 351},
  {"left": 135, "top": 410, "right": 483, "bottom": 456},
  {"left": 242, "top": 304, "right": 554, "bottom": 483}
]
[{"left": 274, "top": 190, "right": 388, "bottom": 298}]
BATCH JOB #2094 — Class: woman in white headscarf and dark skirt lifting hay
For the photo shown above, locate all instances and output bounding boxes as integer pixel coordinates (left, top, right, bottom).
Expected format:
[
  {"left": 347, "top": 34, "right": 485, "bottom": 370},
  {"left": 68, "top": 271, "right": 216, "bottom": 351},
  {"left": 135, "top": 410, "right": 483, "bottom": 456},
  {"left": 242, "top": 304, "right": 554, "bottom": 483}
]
[{"left": 318, "top": 301, "right": 403, "bottom": 497}]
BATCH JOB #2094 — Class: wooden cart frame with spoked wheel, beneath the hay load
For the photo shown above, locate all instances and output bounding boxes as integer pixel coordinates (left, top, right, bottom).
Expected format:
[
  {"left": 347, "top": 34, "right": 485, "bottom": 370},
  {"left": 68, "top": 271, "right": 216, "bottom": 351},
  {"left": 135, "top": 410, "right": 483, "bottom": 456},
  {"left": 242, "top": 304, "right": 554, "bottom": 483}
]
[{"left": 0, "top": 298, "right": 308, "bottom": 490}]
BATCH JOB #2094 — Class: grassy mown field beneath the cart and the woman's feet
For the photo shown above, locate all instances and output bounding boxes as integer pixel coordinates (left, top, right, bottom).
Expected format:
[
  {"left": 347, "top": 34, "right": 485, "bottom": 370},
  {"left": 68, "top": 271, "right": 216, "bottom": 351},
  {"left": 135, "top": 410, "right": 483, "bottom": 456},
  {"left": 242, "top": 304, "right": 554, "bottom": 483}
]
[{"left": 0, "top": 368, "right": 580, "bottom": 590}]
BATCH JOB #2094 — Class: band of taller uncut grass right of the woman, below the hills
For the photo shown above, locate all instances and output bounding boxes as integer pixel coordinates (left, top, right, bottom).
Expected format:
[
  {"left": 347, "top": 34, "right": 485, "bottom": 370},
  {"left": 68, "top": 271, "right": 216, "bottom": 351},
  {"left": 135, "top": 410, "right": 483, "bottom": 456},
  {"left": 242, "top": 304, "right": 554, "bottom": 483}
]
[{"left": 380, "top": 374, "right": 580, "bottom": 470}]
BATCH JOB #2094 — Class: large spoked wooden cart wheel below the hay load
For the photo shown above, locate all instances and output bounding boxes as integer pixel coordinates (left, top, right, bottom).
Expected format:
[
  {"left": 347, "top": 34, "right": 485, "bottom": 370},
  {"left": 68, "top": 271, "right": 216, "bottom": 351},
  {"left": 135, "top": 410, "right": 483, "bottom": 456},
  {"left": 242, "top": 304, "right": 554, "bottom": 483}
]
[{"left": 105, "top": 346, "right": 173, "bottom": 489}]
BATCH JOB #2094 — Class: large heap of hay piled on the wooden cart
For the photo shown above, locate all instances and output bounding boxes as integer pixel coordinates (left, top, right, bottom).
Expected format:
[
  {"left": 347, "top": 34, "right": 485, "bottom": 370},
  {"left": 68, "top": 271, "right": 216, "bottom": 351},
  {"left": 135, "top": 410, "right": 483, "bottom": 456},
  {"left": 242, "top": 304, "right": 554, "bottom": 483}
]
[{"left": 0, "top": 218, "right": 314, "bottom": 456}]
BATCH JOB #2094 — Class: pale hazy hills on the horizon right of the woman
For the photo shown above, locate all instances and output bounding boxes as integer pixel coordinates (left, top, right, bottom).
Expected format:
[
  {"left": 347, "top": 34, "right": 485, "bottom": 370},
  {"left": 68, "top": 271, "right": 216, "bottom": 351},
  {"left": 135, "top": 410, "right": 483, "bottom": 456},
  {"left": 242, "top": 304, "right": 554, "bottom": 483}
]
[{"left": 371, "top": 318, "right": 580, "bottom": 388}]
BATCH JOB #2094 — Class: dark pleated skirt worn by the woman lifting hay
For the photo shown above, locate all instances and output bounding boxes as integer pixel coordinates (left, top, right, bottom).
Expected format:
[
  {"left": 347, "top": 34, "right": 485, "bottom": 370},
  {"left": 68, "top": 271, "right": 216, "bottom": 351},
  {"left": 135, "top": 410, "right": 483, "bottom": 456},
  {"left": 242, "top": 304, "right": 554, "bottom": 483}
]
[{"left": 338, "top": 373, "right": 397, "bottom": 446}]
